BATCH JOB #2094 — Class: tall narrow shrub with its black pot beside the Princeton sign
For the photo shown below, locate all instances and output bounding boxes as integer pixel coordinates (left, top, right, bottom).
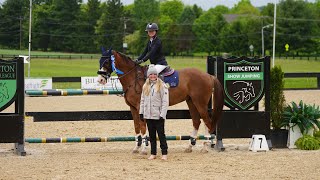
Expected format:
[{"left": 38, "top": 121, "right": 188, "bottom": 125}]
[{"left": 270, "top": 66, "right": 288, "bottom": 148}]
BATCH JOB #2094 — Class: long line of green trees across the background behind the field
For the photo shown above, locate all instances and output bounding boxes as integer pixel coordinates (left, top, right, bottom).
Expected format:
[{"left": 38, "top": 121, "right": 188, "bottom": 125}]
[{"left": 0, "top": 0, "right": 320, "bottom": 55}]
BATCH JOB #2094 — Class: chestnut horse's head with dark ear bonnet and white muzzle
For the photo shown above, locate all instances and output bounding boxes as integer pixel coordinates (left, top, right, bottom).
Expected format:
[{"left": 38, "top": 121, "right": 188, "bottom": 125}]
[{"left": 97, "top": 47, "right": 113, "bottom": 84}]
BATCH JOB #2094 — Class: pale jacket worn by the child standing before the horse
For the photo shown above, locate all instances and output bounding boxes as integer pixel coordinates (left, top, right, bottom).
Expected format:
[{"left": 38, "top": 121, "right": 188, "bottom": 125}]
[{"left": 139, "top": 82, "right": 169, "bottom": 120}]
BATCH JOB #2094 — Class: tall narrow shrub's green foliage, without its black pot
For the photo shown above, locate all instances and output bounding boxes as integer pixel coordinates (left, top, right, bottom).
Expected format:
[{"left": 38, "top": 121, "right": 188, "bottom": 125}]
[{"left": 270, "top": 66, "right": 285, "bottom": 129}]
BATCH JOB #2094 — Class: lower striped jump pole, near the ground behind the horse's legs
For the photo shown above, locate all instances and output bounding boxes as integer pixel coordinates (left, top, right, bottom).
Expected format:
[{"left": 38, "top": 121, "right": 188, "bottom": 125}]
[{"left": 25, "top": 135, "right": 205, "bottom": 143}]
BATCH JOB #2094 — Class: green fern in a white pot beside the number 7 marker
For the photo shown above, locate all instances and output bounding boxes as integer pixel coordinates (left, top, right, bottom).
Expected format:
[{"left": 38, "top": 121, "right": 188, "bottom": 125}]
[{"left": 283, "top": 101, "right": 320, "bottom": 148}]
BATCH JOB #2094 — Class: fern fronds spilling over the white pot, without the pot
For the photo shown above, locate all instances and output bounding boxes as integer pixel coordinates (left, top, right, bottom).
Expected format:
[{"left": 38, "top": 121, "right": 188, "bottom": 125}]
[{"left": 282, "top": 100, "right": 320, "bottom": 134}]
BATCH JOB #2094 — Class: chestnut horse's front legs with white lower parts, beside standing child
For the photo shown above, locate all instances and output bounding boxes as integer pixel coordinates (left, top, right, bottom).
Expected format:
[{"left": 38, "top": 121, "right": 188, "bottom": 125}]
[{"left": 130, "top": 107, "right": 148, "bottom": 154}]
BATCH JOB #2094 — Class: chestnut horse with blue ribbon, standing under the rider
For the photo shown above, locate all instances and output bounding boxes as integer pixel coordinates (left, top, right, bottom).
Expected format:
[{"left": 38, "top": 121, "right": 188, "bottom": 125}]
[{"left": 98, "top": 48, "right": 224, "bottom": 154}]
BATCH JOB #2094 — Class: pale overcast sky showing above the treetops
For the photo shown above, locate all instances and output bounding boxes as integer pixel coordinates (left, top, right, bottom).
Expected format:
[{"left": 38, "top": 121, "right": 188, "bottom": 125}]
[{"left": 0, "top": 0, "right": 315, "bottom": 10}]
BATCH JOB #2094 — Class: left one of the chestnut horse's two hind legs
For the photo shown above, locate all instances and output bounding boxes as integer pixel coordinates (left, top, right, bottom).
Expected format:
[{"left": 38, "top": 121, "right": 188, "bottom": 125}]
[{"left": 185, "top": 98, "right": 201, "bottom": 152}]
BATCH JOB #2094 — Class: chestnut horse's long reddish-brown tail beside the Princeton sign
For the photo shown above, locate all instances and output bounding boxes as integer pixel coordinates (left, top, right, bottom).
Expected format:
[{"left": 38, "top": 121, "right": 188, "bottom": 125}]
[{"left": 210, "top": 76, "right": 224, "bottom": 134}]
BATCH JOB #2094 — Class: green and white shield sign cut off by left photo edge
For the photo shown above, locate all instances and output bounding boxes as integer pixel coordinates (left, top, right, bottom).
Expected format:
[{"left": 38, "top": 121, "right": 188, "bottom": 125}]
[{"left": 0, "top": 60, "right": 17, "bottom": 111}]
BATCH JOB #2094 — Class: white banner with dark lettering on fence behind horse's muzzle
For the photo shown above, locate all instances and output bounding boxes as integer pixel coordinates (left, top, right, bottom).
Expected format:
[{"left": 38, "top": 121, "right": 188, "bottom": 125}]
[{"left": 81, "top": 76, "right": 122, "bottom": 89}]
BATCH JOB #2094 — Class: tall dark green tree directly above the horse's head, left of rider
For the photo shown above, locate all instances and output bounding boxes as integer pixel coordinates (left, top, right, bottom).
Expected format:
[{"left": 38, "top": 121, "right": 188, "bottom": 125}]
[{"left": 95, "top": 0, "right": 124, "bottom": 51}]
